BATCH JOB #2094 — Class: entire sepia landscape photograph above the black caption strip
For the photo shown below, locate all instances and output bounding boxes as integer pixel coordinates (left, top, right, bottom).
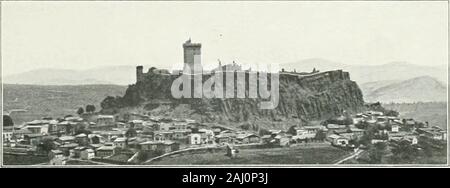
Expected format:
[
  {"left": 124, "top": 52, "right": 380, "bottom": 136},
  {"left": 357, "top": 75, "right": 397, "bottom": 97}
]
[{"left": 0, "top": 1, "right": 449, "bottom": 167}]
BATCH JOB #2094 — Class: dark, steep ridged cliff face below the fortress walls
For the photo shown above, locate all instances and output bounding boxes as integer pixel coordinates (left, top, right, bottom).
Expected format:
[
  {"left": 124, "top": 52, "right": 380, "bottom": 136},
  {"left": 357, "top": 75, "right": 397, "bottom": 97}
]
[{"left": 101, "top": 70, "right": 364, "bottom": 126}]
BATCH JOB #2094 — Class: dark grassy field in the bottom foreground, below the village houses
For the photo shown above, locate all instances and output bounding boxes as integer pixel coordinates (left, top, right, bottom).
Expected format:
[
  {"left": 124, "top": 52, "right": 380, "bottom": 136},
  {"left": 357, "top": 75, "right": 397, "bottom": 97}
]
[{"left": 148, "top": 144, "right": 348, "bottom": 165}]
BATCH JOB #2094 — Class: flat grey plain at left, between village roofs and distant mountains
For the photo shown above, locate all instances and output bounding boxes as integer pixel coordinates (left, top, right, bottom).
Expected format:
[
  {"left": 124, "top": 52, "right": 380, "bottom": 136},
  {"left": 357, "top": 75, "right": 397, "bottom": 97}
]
[{"left": 3, "top": 84, "right": 126, "bottom": 124}]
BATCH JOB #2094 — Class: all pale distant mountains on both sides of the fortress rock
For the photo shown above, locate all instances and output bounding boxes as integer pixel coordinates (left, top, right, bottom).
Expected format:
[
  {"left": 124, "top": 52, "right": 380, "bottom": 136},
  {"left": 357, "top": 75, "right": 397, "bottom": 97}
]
[{"left": 3, "top": 58, "right": 448, "bottom": 102}]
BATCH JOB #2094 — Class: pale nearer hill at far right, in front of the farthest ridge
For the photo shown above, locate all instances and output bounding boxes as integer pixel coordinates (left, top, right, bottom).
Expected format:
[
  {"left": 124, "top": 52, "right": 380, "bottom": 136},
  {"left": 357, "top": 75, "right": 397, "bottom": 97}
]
[{"left": 360, "top": 76, "right": 447, "bottom": 103}]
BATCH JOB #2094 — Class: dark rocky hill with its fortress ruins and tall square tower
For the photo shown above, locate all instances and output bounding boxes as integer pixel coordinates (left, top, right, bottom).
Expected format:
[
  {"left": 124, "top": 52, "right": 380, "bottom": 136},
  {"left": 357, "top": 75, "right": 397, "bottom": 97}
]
[{"left": 102, "top": 40, "right": 364, "bottom": 126}]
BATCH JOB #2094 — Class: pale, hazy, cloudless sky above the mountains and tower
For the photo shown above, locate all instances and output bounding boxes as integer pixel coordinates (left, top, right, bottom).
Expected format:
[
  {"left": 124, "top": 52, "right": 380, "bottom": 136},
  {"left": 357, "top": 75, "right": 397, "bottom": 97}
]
[{"left": 1, "top": 1, "right": 448, "bottom": 75}]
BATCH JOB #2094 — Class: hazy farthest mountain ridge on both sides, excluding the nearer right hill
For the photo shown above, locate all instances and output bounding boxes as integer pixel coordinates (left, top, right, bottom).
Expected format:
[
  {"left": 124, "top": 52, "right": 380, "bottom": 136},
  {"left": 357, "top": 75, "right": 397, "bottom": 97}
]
[{"left": 3, "top": 58, "right": 448, "bottom": 85}]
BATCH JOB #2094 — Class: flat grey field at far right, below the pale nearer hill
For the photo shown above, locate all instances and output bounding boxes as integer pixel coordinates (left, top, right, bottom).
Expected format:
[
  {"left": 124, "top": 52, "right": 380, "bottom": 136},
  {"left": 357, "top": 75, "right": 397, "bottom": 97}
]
[{"left": 383, "top": 102, "right": 448, "bottom": 129}]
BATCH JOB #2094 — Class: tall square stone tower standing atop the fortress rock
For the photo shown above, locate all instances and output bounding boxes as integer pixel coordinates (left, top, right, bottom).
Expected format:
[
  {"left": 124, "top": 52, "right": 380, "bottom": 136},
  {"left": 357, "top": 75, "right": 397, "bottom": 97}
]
[{"left": 183, "top": 39, "right": 203, "bottom": 73}]
